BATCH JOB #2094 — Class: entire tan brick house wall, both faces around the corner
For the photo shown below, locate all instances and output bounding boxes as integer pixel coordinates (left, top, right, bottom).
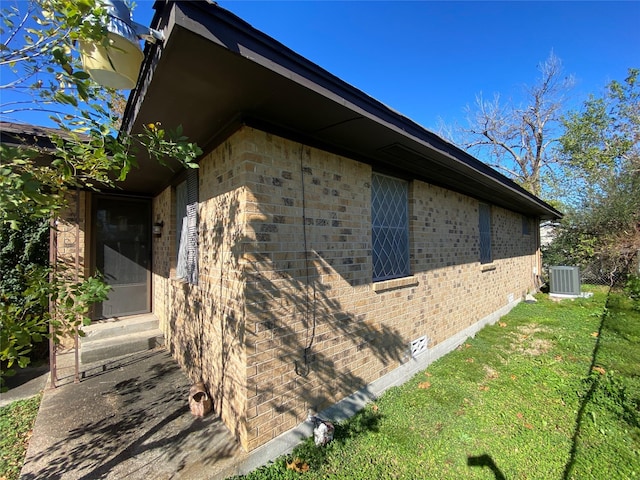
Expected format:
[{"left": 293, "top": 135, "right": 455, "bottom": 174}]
[{"left": 154, "top": 127, "right": 537, "bottom": 450}]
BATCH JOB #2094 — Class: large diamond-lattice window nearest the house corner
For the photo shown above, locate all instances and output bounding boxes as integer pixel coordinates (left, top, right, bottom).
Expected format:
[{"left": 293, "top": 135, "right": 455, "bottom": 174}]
[{"left": 371, "top": 174, "right": 410, "bottom": 281}]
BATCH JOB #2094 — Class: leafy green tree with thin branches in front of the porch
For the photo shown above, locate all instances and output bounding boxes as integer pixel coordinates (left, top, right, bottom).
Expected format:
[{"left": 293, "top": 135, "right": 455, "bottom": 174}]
[{"left": 0, "top": 0, "right": 202, "bottom": 388}]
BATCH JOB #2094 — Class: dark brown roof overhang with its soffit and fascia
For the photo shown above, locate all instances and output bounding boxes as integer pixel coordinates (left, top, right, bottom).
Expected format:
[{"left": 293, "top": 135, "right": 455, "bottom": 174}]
[{"left": 123, "top": 0, "right": 562, "bottom": 219}]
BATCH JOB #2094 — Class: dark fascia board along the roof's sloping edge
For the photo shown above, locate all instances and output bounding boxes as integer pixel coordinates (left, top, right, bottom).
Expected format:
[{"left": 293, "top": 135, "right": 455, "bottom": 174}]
[{"left": 123, "top": 0, "right": 562, "bottom": 218}]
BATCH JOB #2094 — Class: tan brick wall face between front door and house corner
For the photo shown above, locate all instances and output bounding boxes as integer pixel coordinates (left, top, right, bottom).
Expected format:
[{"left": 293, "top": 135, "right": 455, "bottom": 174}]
[{"left": 153, "top": 134, "right": 246, "bottom": 442}]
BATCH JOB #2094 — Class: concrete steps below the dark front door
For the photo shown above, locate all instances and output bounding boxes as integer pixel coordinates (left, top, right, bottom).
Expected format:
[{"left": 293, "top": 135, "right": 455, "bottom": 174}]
[{"left": 80, "top": 315, "right": 164, "bottom": 364}]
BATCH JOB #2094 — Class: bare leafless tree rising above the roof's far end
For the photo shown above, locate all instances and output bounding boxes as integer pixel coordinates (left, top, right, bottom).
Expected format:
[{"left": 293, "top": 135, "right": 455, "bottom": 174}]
[{"left": 459, "top": 52, "right": 573, "bottom": 195}]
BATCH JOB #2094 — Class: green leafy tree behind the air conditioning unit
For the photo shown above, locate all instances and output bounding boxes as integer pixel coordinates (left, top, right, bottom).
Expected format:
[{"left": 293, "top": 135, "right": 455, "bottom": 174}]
[{"left": 547, "top": 68, "right": 640, "bottom": 281}]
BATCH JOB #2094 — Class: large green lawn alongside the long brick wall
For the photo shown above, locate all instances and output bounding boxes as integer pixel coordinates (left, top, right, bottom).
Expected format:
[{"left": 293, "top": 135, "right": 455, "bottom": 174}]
[{"left": 235, "top": 289, "right": 640, "bottom": 480}]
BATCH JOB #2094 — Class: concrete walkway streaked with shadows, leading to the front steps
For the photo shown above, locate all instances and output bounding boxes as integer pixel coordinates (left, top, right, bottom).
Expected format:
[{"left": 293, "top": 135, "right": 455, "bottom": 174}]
[{"left": 16, "top": 348, "right": 247, "bottom": 480}]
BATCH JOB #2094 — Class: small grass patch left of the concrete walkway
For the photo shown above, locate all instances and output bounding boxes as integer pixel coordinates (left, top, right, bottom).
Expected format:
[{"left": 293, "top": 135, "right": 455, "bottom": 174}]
[{"left": 0, "top": 395, "right": 41, "bottom": 480}]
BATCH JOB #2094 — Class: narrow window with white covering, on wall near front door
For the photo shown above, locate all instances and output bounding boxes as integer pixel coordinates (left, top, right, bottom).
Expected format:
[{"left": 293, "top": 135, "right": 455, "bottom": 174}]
[{"left": 176, "top": 169, "right": 198, "bottom": 285}]
